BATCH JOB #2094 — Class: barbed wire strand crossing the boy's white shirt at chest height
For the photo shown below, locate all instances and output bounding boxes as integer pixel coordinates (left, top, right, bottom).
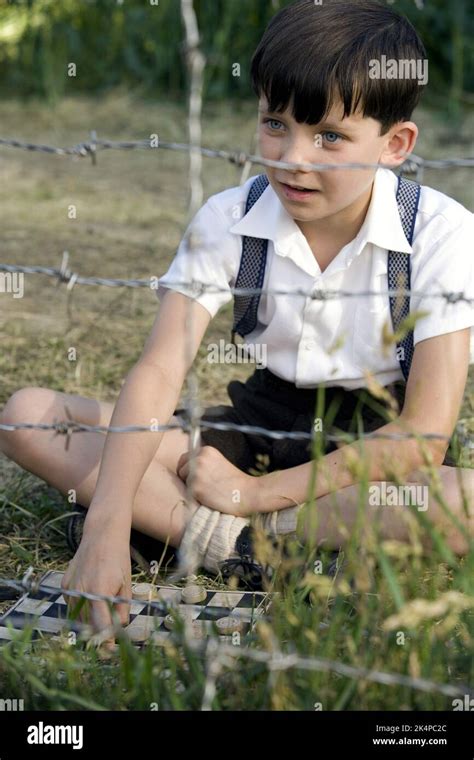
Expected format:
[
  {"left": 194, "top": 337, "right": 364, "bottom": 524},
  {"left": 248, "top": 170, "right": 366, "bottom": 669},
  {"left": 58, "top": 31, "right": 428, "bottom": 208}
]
[{"left": 0, "top": 251, "right": 474, "bottom": 305}]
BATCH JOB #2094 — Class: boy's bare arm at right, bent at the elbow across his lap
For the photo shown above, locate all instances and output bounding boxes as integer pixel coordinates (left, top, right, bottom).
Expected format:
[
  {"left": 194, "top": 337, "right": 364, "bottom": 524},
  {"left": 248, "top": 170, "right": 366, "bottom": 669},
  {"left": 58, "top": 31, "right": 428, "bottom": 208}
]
[{"left": 252, "top": 328, "right": 470, "bottom": 512}]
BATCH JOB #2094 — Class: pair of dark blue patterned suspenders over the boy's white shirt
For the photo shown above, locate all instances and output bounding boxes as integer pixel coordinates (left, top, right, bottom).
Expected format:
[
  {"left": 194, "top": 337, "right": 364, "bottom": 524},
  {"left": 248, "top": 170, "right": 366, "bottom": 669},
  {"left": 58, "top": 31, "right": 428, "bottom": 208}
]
[{"left": 232, "top": 174, "right": 421, "bottom": 381}]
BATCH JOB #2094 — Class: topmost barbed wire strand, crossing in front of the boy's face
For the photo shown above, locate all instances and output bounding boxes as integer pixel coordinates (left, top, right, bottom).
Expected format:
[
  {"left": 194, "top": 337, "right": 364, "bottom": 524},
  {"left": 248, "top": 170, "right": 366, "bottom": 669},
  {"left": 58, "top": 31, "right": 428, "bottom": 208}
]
[{"left": 0, "top": 132, "right": 474, "bottom": 173}]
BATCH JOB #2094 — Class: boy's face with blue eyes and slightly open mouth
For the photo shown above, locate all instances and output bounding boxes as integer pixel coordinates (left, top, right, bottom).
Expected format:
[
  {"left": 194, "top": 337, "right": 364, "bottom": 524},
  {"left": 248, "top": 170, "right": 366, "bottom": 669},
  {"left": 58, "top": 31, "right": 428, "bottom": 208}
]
[{"left": 258, "top": 96, "right": 417, "bottom": 237}]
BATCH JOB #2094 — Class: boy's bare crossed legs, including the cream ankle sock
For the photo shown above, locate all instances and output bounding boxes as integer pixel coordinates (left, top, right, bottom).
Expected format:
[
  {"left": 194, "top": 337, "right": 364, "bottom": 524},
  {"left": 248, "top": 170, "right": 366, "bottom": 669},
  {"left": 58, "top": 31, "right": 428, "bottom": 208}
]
[{"left": 0, "top": 388, "right": 474, "bottom": 571}]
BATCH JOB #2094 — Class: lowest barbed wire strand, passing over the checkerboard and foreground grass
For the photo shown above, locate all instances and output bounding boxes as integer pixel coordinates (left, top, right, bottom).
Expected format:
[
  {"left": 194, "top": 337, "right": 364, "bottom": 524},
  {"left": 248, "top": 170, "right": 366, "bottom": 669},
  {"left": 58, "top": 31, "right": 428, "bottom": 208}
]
[{"left": 0, "top": 567, "right": 474, "bottom": 709}]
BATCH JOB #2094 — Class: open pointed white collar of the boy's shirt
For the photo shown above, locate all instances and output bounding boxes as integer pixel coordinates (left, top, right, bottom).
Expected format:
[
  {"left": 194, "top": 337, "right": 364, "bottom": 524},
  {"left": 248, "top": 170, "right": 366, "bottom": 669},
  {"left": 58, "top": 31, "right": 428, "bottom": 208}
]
[{"left": 230, "top": 168, "right": 413, "bottom": 268}]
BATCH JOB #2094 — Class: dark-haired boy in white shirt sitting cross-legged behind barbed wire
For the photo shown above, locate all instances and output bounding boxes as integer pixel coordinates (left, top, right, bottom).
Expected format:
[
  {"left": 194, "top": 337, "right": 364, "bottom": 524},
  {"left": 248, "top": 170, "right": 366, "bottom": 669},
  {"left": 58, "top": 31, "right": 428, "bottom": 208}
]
[{"left": 1, "top": 0, "right": 474, "bottom": 628}]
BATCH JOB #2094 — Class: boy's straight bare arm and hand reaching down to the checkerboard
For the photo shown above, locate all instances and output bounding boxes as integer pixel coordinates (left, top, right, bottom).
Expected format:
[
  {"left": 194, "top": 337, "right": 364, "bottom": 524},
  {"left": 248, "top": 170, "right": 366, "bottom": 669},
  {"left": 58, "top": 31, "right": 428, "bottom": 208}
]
[{"left": 62, "top": 291, "right": 211, "bottom": 641}]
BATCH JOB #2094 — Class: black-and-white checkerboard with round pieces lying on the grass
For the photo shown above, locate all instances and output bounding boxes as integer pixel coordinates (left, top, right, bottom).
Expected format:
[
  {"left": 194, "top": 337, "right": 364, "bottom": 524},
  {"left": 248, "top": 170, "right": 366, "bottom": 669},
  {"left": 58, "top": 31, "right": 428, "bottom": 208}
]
[{"left": 0, "top": 571, "right": 271, "bottom": 645}]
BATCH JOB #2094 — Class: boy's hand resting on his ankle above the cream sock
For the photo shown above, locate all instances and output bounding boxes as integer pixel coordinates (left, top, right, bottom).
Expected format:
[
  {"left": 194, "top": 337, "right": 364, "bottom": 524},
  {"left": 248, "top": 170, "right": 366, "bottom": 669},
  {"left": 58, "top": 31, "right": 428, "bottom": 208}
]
[{"left": 176, "top": 446, "right": 257, "bottom": 517}]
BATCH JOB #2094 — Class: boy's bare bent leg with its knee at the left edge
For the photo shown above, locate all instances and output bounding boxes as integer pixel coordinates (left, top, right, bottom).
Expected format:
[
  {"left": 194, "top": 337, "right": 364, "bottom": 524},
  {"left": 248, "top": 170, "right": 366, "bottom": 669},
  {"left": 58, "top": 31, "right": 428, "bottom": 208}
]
[{"left": 0, "top": 388, "right": 198, "bottom": 547}]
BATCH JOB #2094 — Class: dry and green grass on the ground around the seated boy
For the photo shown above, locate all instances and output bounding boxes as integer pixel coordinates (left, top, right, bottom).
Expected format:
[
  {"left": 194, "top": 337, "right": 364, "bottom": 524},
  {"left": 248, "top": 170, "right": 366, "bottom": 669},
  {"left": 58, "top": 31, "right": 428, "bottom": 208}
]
[{"left": 0, "top": 92, "right": 474, "bottom": 710}]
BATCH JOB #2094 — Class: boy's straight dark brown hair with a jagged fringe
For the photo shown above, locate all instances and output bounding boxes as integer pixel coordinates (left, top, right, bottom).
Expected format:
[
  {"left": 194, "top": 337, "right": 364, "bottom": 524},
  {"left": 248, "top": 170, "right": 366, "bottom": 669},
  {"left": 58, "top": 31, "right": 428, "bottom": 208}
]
[{"left": 250, "top": 0, "right": 426, "bottom": 135}]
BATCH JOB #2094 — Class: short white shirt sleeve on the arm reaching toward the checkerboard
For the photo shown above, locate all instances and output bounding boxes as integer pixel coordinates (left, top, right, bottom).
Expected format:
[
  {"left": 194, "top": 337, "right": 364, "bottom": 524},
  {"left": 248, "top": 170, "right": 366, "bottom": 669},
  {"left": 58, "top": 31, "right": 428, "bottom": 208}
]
[{"left": 156, "top": 200, "right": 238, "bottom": 317}]
